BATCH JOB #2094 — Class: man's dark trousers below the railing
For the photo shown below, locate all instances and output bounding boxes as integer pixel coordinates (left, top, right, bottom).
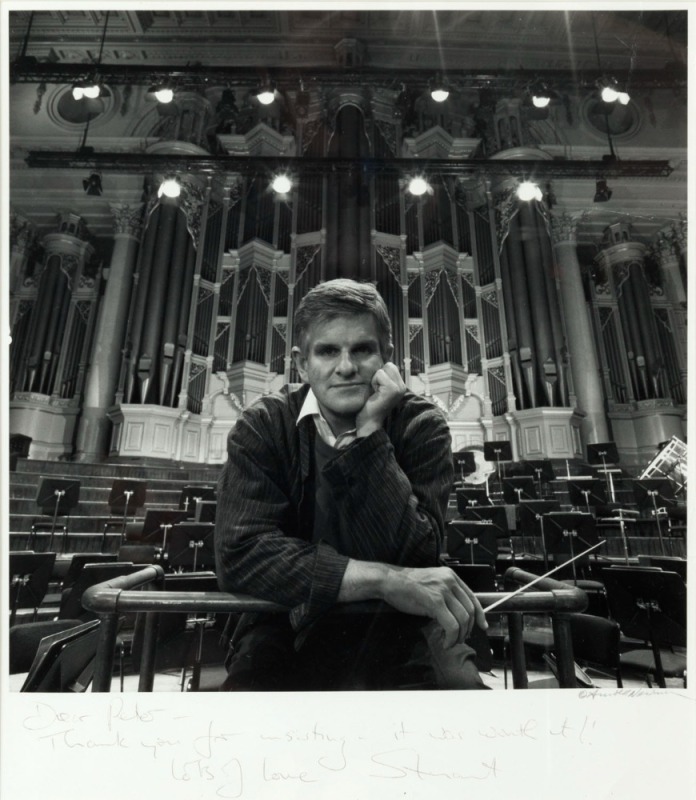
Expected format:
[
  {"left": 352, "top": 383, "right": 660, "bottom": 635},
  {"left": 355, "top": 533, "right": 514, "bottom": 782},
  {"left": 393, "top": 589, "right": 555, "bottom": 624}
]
[{"left": 220, "top": 612, "right": 489, "bottom": 692}]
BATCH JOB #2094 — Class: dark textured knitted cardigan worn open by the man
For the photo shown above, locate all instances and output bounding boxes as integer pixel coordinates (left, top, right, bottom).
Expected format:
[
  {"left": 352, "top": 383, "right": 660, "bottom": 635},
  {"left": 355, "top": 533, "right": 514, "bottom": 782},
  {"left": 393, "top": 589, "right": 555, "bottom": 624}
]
[{"left": 215, "top": 385, "right": 453, "bottom": 630}]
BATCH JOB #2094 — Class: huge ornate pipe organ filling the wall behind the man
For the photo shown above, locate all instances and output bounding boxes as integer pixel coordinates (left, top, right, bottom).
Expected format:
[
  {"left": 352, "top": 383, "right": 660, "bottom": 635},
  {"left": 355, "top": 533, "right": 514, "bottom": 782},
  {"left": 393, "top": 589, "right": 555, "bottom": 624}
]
[{"left": 12, "top": 87, "right": 686, "bottom": 463}]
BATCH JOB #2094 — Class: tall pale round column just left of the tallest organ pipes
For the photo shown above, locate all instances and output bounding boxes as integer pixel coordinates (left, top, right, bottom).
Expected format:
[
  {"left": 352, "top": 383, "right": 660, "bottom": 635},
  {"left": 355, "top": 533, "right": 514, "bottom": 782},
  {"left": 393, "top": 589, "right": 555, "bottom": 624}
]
[{"left": 76, "top": 203, "right": 142, "bottom": 461}]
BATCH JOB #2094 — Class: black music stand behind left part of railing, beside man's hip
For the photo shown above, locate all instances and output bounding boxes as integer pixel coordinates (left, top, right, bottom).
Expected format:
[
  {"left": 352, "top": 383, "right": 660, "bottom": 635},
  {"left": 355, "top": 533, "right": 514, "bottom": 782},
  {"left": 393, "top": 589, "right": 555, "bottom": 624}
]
[{"left": 132, "top": 571, "right": 228, "bottom": 692}]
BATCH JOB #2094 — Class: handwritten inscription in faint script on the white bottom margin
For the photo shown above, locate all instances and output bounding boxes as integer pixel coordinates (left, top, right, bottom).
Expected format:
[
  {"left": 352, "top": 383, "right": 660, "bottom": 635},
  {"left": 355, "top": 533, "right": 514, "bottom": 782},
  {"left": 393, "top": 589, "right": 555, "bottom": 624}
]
[{"left": 16, "top": 697, "right": 608, "bottom": 800}]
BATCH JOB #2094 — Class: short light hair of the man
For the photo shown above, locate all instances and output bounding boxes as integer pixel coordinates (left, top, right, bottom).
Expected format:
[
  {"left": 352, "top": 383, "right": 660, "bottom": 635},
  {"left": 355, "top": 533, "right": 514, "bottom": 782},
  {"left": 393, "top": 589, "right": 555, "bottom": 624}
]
[{"left": 293, "top": 278, "right": 392, "bottom": 357}]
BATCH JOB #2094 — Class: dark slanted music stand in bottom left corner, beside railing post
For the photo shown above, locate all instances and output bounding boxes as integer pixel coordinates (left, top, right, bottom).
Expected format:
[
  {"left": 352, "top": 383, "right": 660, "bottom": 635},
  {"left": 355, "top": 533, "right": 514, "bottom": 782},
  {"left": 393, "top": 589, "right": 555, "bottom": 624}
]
[{"left": 20, "top": 619, "right": 99, "bottom": 692}]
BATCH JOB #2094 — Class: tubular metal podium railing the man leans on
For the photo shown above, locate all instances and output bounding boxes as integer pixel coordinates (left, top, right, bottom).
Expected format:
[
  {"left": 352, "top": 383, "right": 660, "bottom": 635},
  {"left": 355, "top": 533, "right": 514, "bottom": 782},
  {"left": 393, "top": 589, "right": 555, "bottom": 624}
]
[{"left": 82, "top": 565, "right": 587, "bottom": 692}]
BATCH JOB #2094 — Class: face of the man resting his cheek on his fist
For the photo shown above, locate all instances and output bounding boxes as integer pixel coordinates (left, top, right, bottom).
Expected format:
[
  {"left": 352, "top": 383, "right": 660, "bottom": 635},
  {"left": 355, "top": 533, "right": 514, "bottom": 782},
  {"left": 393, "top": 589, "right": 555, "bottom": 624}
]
[{"left": 293, "top": 314, "right": 391, "bottom": 435}]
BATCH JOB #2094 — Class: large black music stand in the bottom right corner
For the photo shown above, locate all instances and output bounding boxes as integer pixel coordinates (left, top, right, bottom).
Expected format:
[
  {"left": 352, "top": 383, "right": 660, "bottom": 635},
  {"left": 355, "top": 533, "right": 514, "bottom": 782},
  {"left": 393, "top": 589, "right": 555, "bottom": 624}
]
[{"left": 602, "top": 566, "right": 686, "bottom": 688}]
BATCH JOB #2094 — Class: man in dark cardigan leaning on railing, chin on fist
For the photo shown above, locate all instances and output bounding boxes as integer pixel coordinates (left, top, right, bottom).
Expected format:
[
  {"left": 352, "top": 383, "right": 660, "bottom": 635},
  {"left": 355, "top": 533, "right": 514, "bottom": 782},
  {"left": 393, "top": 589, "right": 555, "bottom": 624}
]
[{"left": 215, "top": 279, "right": 487, "bottom": 690}]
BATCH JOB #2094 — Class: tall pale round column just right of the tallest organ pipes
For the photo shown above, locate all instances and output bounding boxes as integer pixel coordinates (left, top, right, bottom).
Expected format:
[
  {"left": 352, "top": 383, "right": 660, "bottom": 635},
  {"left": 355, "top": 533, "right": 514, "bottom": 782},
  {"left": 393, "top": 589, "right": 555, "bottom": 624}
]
[{"left": 551, "top": 213, "right": 609, "bottom": 444}]
